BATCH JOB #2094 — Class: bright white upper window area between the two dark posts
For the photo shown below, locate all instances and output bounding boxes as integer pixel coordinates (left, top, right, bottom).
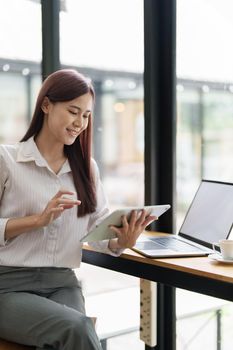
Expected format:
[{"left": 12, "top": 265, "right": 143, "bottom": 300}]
[{"left": 60, "top": 0, "right": 143, "bottom": 72}]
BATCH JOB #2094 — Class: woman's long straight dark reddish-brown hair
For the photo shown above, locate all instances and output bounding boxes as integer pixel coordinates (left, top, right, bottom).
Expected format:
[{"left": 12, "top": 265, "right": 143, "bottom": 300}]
[{"left": 20, "top": 69, "right": 96, "bottom": 216}]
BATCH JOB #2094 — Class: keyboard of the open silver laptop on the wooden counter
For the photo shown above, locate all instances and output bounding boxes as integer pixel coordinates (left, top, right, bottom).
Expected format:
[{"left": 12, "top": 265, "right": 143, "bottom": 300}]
[{"left": 150, "top": 237, "right": 204, "bottom": 252}]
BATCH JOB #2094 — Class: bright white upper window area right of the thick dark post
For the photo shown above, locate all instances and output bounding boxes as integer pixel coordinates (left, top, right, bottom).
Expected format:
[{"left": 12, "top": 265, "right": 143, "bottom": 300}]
[{"left": 177, "top": 0, "right": 233, "bottom": 83}]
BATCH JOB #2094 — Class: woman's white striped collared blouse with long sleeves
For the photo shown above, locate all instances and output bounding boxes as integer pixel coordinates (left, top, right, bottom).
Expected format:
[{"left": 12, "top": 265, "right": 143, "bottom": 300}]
[{"left": 0, "top": 137, "right": 122, "bottom": 268}]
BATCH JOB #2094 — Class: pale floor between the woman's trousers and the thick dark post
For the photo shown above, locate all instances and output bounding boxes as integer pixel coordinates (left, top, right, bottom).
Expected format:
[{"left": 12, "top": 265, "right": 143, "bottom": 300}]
[{"left": 76, "top": 264, "right": 144, "bottom": 350}]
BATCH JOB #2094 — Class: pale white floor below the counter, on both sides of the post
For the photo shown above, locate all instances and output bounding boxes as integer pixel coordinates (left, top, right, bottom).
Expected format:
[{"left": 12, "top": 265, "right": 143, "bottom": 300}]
[{"left": 76, "top": 264, "right": 233, "bottom": 350}]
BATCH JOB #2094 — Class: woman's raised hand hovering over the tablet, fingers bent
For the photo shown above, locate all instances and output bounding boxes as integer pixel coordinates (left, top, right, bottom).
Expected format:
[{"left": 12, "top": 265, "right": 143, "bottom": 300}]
[{"left": 38, "top": 190, "right": 81, "bottom": 227}]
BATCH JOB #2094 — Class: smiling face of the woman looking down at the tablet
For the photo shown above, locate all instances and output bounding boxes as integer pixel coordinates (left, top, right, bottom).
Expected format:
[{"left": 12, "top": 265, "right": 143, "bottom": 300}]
[{"left": 42, "top": 93, "right": 93, "bottom": 145}]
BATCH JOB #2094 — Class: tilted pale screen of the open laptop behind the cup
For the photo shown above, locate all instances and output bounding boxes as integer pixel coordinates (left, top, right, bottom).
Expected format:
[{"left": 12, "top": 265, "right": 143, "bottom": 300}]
[{"left": 179, "top": 180, "right": 233, "bottom": 248}]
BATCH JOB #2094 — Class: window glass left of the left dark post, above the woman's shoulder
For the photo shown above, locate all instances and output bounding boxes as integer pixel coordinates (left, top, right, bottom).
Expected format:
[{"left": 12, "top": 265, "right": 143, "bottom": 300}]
[{"left": 0, "top": 0, "right": 42, "bottom": 143}]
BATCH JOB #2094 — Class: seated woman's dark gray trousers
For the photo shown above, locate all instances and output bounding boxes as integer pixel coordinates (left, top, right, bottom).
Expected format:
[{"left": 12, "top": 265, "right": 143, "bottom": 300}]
[{"left": 0, "top": 266, "right": 101, "bottom": 350}]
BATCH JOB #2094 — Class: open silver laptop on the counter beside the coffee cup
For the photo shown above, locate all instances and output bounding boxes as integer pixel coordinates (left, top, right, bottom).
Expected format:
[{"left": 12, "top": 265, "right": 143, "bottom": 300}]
[{"left": 132, "top": 180, "right": 233, "bottom": 258}]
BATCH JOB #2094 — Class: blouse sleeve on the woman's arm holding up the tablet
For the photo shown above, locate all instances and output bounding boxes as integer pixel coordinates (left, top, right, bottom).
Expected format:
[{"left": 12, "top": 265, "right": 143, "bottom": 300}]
[{"left": 88, "top": 160, "right": 124, "bottom": 256}]
